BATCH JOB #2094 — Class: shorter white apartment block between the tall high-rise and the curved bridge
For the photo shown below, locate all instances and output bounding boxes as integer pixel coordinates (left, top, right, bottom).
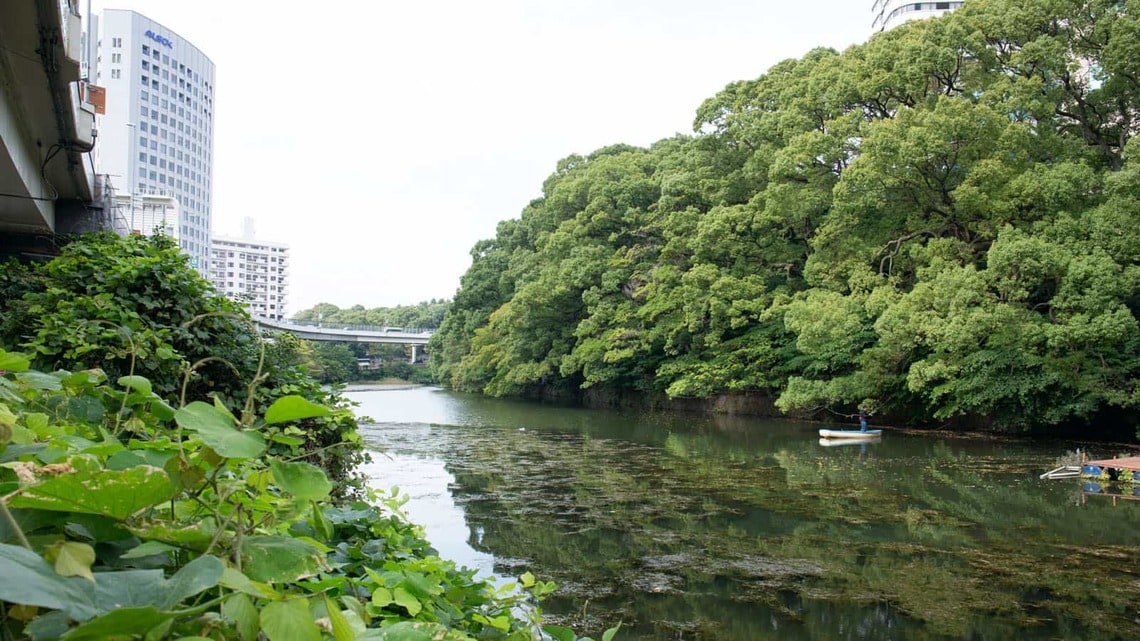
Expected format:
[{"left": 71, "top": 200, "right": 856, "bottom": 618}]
[{"left": 210, "top": 236, "right": 288, "bottom": 321}]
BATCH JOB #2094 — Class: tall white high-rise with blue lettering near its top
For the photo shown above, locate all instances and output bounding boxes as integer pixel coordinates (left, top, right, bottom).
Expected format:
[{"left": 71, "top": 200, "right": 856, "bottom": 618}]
[{"left": 91, "top": 9, "right": 214, "bottom": 275}]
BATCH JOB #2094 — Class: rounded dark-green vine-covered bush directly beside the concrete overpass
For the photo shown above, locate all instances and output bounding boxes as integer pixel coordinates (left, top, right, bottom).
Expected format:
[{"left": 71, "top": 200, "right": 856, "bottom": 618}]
[{"left": 0, "top": 234, "right": 261, "bottom": 400}]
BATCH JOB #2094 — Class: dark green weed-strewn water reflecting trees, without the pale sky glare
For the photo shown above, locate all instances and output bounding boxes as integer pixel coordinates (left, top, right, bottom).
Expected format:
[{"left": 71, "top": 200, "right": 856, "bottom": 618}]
[{"left": 428, "top": 419, "right": 1140, "bottom": 639}]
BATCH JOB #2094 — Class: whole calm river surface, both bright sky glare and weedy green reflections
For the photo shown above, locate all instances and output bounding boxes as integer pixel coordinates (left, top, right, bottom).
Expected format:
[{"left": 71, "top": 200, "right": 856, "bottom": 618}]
[{"left": 349, "top": 388, "right": 1140, "bottom": 641}]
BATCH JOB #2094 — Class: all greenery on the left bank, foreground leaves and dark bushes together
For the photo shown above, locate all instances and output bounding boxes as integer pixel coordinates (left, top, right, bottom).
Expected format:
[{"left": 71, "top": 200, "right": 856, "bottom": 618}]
[{"left": 0, "top": 235, "right": 612, "bottom": 641}]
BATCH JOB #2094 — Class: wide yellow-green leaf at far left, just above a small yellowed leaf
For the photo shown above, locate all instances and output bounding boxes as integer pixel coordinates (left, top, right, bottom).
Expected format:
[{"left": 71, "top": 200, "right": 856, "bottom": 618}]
[{"left": 8, "top": 465, "right": 174, "bottom": 520}]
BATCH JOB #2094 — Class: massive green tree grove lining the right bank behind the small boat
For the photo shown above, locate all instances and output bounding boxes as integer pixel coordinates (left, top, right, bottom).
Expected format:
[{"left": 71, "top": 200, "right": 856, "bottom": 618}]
[{"left": 430, "top": 0, "right": 1140, "bottom": 435}]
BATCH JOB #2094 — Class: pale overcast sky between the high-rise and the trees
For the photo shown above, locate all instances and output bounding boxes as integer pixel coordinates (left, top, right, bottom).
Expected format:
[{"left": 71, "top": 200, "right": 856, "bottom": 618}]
[{"left": 92, "top": 0, "right": 872, "bottom": 314}]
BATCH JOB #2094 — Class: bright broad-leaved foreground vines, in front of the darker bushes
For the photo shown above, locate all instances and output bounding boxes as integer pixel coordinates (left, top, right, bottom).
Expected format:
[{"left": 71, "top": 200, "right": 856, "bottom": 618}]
[{"left": 0, "top": 351, "right": 570, "bottom": 641}]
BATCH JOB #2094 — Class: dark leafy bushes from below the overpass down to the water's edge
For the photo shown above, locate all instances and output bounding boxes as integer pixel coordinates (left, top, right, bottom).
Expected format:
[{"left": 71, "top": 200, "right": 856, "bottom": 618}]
[{"left": 0, "top": 234, "right": 364, "bottom": 480}]
